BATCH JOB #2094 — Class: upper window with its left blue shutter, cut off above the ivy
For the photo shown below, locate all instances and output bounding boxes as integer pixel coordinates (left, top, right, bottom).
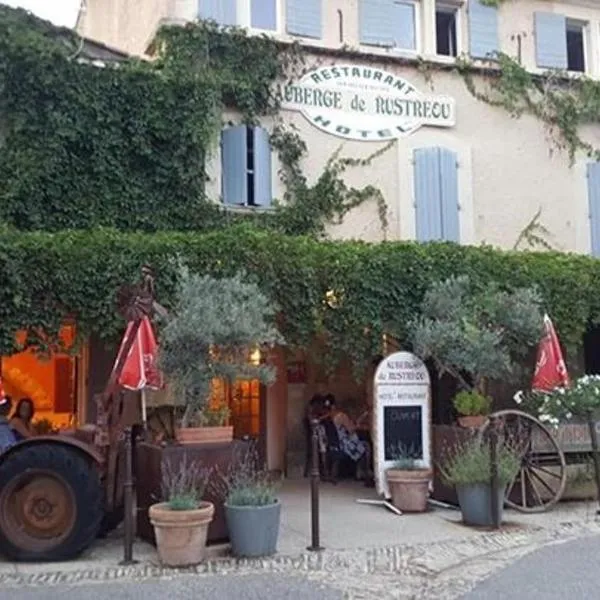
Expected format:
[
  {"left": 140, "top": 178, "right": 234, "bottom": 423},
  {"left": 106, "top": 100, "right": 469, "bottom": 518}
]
[{"left": 198, "top": 0, "right": 279, "bottom": 31}]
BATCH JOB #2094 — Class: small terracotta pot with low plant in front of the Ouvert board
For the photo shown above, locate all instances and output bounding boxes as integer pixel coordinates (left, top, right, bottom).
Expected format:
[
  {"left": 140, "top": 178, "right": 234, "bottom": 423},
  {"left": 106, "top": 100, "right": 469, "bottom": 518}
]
[{"left": 386, "top": 444, "right": 432, "bottom": 512}]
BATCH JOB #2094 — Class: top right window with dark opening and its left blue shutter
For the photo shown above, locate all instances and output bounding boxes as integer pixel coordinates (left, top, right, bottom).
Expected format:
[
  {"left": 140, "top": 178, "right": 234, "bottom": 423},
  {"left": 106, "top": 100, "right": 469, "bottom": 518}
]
[{"left": 535, "top": 12, "right": 587, "bottom": 72}]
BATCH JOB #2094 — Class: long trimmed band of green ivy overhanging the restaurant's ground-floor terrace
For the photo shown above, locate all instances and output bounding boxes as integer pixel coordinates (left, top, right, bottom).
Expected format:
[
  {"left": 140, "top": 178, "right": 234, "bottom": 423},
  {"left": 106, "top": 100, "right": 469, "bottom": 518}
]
[{"left": 0, "top": 226, "right": 600, "bottom": 366}]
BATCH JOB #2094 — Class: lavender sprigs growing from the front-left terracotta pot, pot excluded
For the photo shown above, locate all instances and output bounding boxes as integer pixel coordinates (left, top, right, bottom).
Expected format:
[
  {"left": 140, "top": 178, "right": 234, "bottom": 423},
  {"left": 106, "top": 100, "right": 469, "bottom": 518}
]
[{"left": 161, "top": 454, "right": 212, "bottom": 510}]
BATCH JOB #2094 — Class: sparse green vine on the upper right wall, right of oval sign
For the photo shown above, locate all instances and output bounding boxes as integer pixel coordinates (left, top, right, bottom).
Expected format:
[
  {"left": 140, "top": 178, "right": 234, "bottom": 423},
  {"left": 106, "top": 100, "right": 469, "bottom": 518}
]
[{"left": 457, "top": 51, "right": 600, "bottom": 162}]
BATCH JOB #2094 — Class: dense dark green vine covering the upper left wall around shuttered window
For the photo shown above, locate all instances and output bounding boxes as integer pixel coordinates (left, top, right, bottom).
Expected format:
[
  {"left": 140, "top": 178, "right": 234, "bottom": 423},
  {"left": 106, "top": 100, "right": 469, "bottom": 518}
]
[{"left": 0, "top": 6, "right": 384, "bottom": 234}]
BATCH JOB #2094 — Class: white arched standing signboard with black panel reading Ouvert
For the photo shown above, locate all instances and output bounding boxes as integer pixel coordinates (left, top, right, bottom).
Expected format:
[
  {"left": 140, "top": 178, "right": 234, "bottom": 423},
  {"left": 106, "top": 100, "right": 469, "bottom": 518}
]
[{"left": 373, "top": 352, "right": 431, "bottom": 498}]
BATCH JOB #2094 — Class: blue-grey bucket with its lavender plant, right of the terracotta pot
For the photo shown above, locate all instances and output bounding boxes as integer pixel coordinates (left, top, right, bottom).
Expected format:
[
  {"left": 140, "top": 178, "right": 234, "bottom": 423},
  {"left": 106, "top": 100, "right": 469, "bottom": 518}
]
[{"left": 216, "top": 445, "right": 281, "bottom": 557}]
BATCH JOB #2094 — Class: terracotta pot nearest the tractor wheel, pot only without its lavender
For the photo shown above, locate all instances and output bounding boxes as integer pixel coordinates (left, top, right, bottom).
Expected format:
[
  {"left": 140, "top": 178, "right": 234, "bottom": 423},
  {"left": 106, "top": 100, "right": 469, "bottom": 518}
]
[{"left": 150, "top": 502, "right": 215, "bottom": 567}]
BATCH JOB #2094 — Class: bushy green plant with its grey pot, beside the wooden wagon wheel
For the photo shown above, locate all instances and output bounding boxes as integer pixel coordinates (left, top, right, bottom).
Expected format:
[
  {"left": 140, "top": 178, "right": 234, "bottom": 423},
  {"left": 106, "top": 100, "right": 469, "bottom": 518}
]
[{"left": 439, "top": 437, "right": 521, "bottom": 527}]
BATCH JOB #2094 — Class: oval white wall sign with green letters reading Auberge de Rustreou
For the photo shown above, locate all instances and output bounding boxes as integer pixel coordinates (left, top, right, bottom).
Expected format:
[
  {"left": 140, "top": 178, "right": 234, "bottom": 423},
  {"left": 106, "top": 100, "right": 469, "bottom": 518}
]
[{"left": 279, "top": 65, "right": 456, "bottom": 141}]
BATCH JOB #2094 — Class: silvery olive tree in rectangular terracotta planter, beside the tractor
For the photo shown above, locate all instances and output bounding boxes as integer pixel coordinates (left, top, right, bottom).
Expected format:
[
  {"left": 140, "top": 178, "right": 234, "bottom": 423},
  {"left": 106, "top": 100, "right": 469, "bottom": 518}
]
[{"left": 159, "top": 266, "right": 283, "bottom": 443}]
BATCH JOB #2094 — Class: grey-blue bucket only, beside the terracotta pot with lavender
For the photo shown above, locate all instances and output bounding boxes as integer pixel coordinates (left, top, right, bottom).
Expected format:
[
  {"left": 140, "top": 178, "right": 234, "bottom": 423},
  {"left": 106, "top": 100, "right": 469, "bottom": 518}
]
[{"left": 225, "top": 500, "right": 281, "bottom": 556}]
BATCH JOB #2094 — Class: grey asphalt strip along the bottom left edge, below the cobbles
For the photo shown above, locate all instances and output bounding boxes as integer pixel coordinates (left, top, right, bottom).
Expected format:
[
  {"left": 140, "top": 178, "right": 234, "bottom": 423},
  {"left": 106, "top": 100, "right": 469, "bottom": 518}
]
[{"left": 0, "top": 574, "right": 344, "bottom": 600}]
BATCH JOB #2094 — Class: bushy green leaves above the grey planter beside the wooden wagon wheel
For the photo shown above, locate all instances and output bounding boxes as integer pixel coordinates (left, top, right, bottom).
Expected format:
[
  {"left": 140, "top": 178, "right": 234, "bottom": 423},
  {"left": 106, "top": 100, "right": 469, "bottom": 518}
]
[{"left": 440, "top": 438, "right": 520, "bottom": 486}]
